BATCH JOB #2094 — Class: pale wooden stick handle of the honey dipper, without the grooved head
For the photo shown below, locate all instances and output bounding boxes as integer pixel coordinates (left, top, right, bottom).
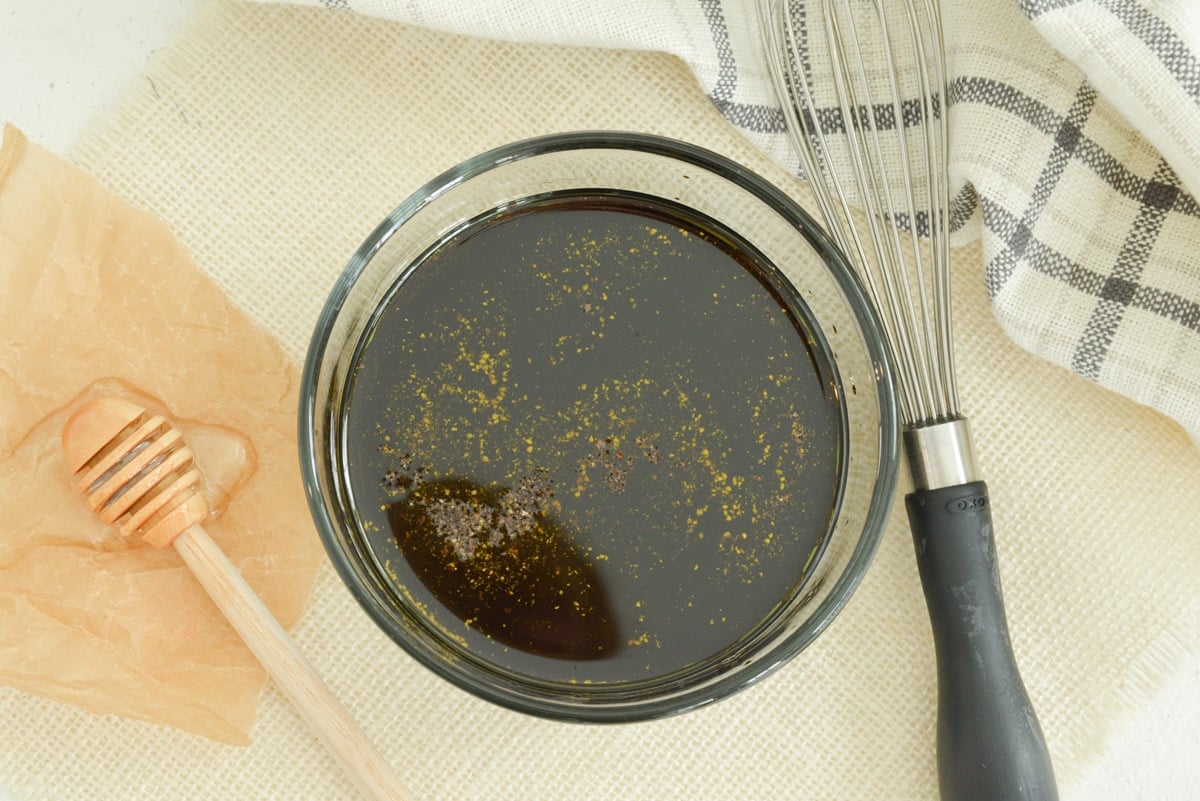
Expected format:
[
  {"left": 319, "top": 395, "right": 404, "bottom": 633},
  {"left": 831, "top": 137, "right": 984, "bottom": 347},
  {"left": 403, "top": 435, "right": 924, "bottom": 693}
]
[{"left": 174, "top": 525, "right": 413, "bottom": 801}]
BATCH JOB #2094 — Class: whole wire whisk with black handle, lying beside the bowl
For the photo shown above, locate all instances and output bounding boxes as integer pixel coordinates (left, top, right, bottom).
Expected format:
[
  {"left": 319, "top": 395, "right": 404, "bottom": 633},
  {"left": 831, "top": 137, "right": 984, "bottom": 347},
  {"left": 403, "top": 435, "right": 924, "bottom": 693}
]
[{"left": 757, "top": 0, "right": 1057, "bottom": 801}]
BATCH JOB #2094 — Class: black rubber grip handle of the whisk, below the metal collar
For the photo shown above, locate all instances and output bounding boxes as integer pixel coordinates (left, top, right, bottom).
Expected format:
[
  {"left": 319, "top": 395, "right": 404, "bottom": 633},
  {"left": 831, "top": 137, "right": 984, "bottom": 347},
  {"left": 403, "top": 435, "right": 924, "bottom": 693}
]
[{"left": 905, "top": 481, "right": 1058, "bottom": 801}]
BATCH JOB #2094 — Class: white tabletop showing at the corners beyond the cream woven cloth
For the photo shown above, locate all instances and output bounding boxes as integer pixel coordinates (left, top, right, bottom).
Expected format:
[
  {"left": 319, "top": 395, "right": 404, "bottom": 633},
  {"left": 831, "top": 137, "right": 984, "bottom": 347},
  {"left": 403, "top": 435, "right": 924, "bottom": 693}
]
[{"left": 0, "top": 0, "right": 1200, "bottom": 801}]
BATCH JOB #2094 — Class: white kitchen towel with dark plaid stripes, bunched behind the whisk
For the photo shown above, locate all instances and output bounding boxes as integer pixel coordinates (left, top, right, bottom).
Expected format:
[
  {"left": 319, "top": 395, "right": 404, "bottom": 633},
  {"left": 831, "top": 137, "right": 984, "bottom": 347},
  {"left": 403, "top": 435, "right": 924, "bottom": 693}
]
[{"left": 272, "top": 0, "right": 1200, "bottom": 439}]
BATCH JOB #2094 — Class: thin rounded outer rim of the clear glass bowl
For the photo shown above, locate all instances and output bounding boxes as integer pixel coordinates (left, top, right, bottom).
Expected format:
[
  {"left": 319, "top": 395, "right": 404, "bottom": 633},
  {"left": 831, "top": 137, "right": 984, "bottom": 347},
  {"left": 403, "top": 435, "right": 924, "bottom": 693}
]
[{"left": 298, "top": 131, "right": 900, "bottom": 722}]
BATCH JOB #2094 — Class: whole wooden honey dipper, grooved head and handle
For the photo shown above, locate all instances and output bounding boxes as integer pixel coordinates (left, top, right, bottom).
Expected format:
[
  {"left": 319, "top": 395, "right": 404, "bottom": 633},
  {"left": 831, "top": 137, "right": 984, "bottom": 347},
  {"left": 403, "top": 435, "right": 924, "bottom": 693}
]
[{"left": 62, "top": 397, "right": 413, "bottom": 801}]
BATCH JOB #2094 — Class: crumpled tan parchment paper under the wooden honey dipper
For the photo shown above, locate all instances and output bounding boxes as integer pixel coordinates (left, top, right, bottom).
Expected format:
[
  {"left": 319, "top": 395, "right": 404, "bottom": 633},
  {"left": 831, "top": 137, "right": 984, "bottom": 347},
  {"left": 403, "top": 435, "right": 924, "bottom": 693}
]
[{"left": 0, "top": 126, "right": 323, "bottom": 743}]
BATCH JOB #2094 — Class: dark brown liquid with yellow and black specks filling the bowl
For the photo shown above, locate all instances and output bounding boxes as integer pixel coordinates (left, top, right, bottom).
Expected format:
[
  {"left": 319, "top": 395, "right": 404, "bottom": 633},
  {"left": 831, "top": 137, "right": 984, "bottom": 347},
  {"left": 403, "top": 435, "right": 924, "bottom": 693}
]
[{"left": 343, "top": 194, "right": 845, "bottom": 683}]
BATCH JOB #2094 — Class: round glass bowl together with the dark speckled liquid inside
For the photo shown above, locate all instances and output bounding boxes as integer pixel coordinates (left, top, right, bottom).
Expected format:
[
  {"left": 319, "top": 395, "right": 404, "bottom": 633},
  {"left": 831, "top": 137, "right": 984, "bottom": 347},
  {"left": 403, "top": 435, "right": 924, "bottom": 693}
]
[{"left": 299, "top": 132, "right": 898, "bottom": 722}]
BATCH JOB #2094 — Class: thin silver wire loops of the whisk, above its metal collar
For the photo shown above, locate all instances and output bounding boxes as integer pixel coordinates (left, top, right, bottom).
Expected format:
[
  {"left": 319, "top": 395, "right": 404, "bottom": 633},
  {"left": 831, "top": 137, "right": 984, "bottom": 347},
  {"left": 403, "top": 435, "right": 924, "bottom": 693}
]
[{"left": 760, "top": 0, "right": 959, "bottom": 426}]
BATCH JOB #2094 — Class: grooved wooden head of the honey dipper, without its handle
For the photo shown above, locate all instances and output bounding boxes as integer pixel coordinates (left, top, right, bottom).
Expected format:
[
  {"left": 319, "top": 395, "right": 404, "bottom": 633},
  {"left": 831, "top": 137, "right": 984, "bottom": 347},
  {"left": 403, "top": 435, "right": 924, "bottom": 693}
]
[{"left": 62, "top": 397, "right": 209, "bottom": 548}]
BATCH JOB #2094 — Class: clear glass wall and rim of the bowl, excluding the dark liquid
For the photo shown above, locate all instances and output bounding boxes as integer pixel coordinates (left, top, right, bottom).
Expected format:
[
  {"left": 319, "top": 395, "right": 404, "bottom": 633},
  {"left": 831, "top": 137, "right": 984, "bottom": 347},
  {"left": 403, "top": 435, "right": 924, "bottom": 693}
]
[{"left": 299, "top": 132, "right": 898, "bottom": 721}]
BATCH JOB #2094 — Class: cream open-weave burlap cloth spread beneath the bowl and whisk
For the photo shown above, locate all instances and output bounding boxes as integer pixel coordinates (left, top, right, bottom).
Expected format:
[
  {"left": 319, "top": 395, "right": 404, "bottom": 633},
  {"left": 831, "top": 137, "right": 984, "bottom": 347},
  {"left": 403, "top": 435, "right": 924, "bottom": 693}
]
[{"left": 0, "top": 1, "right": 1200, "bottom": 801}]
